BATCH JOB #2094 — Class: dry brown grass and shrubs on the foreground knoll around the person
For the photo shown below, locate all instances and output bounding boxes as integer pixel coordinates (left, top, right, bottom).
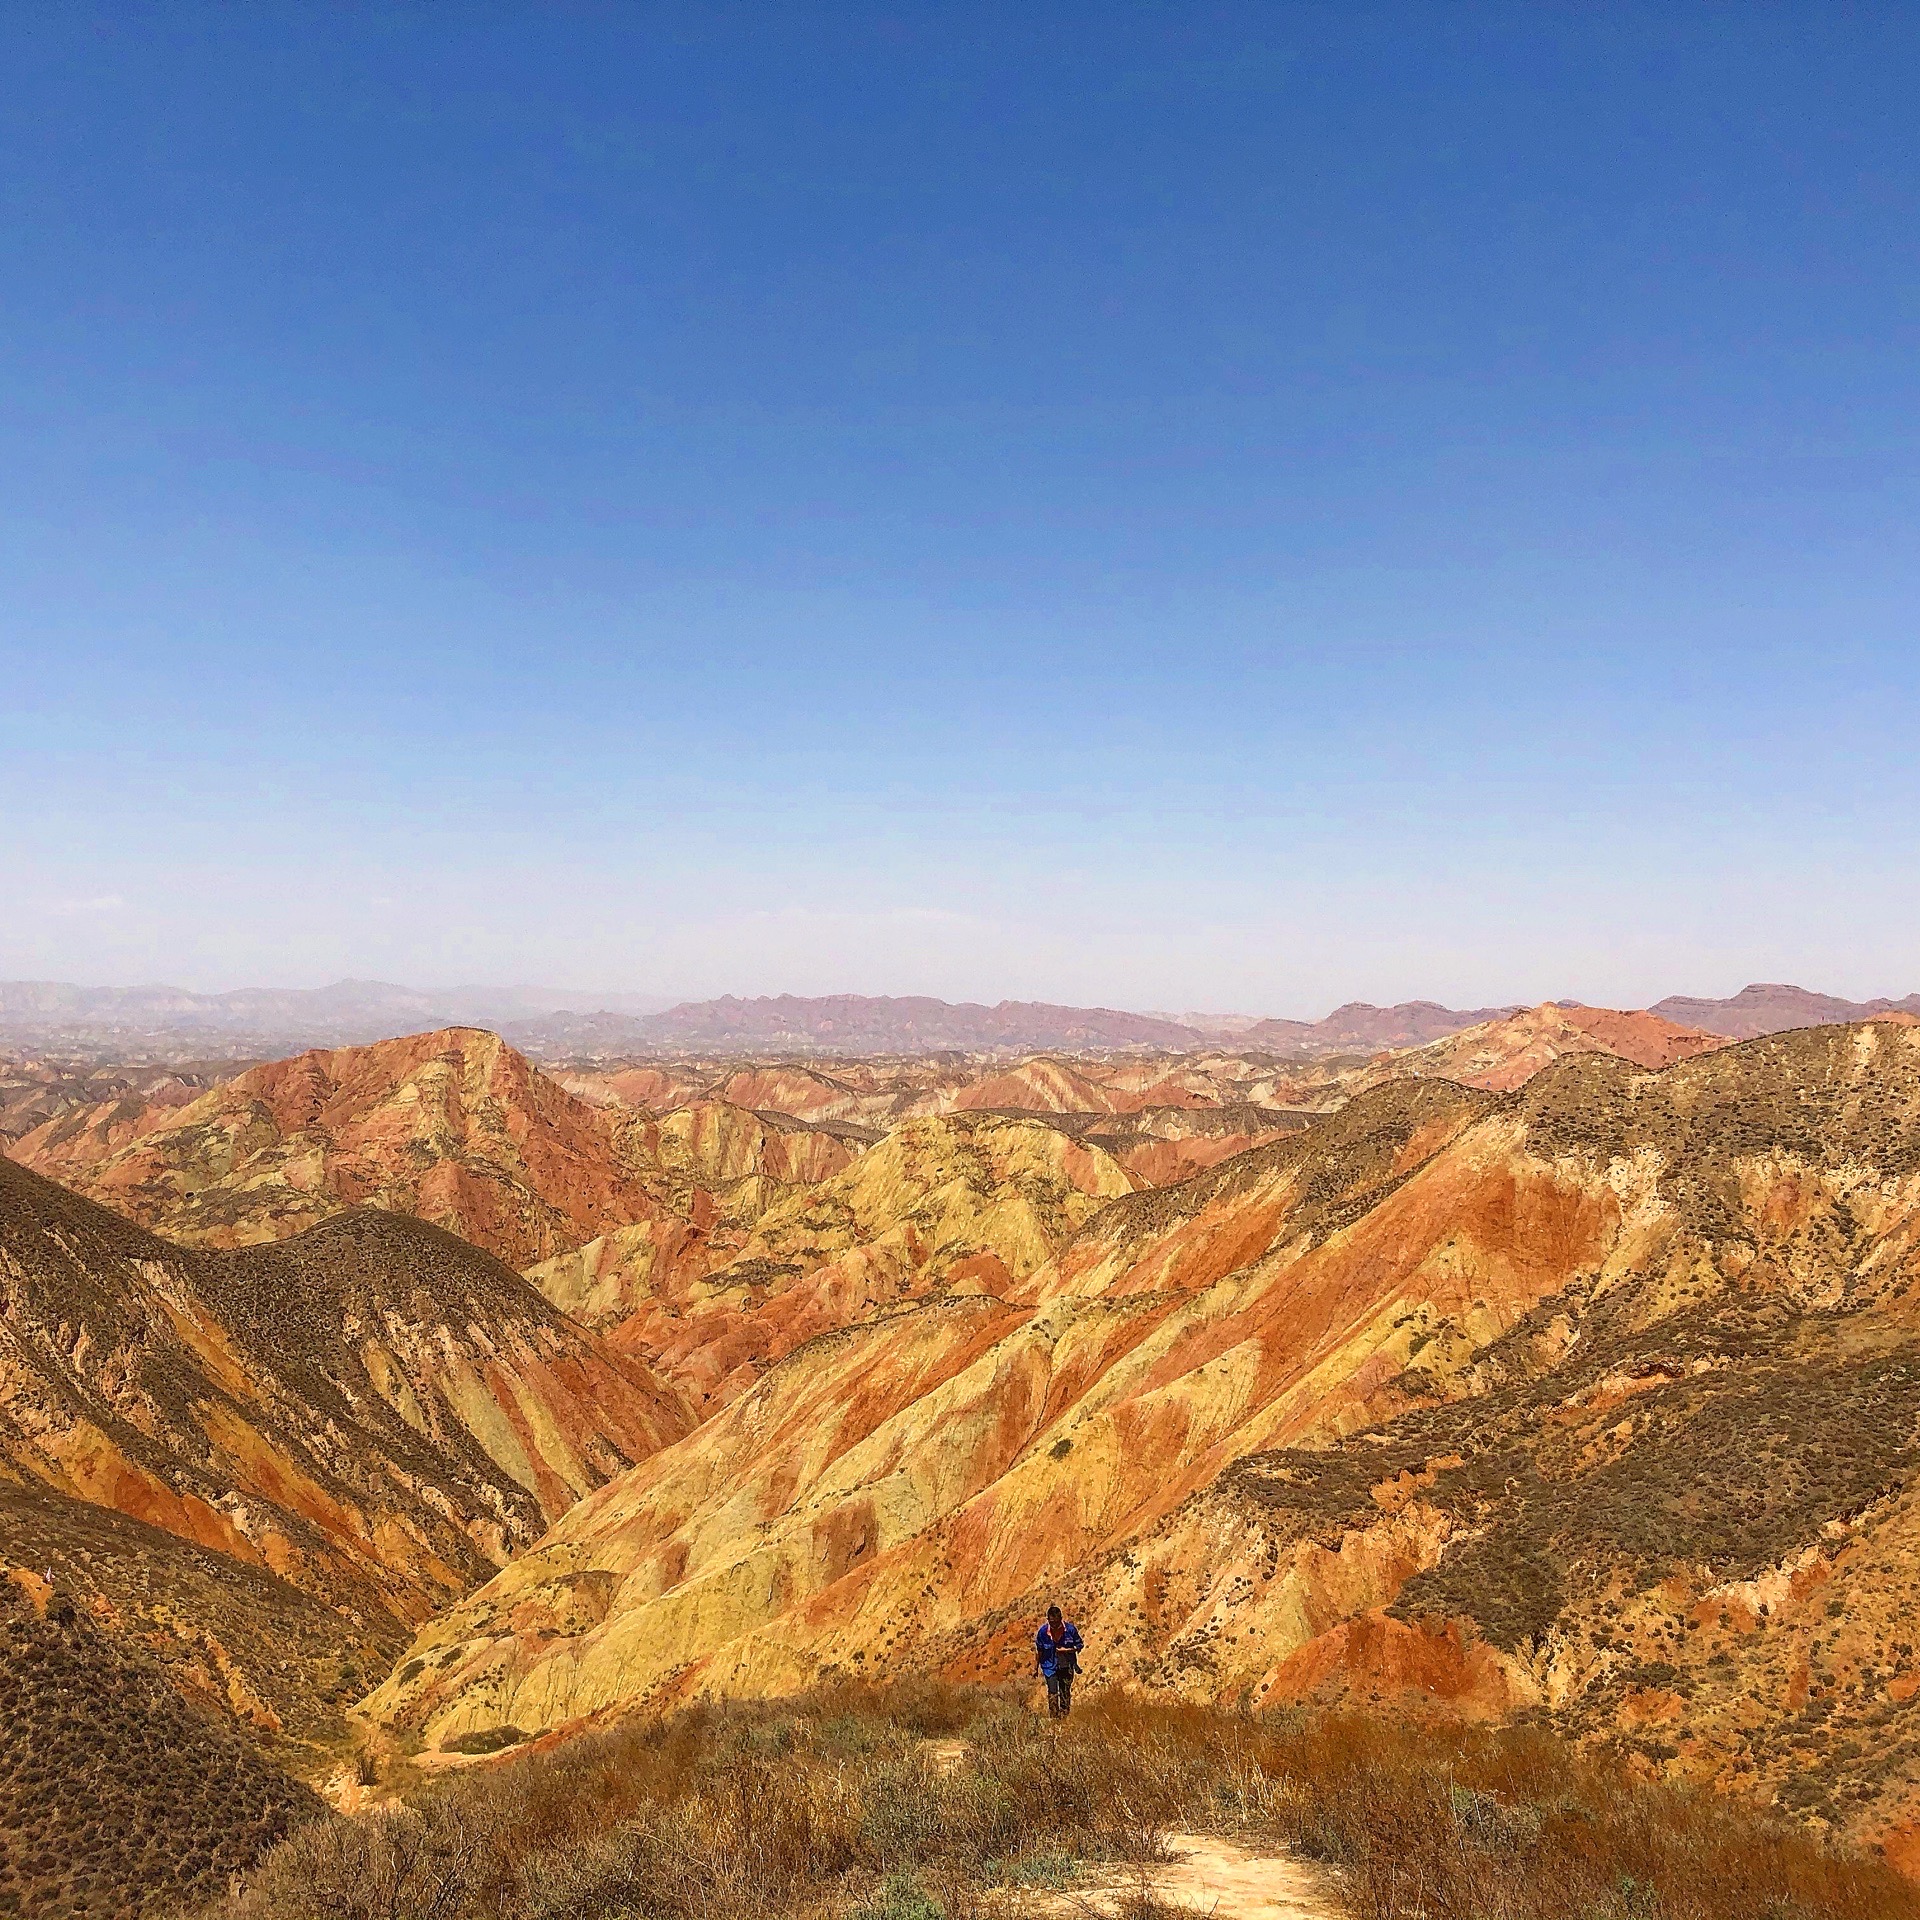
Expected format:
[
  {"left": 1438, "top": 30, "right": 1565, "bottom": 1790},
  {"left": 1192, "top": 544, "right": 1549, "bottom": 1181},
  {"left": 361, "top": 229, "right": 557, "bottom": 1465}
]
[{"left": 202, "top": 1686, "right": 1920, "bottom": 1920}]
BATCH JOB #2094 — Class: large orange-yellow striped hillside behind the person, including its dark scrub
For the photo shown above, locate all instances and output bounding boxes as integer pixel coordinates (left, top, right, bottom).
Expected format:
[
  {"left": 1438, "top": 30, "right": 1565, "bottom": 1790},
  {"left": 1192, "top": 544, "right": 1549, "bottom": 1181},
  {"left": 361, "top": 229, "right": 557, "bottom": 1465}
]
[{"left": 369, "top": 1023, "right": 1920, "bottom": 1851}]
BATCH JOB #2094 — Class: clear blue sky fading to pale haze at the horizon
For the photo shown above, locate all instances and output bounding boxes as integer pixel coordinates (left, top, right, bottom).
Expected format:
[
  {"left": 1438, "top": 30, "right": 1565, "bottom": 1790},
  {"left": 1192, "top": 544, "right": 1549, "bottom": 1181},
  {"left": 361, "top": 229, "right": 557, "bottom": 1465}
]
[{"left": 0, "top": 0, "right": 1920, "bottom": 1014}]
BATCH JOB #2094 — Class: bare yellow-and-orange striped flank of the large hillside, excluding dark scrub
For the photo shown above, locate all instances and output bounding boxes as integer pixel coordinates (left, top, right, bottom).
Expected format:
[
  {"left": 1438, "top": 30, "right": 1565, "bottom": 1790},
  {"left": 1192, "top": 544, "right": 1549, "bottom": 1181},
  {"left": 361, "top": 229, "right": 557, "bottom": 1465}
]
[{"left": 360, "top": 1085, "right": 1484, "bottom": 1738}]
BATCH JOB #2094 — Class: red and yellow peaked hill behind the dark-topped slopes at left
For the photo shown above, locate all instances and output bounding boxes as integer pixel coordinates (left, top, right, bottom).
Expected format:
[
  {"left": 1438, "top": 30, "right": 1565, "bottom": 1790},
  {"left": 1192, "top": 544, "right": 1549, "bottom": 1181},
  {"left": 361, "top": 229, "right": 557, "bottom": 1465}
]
[{"left": 12, "top": 1027, "right": 860, "bottom": 1267}]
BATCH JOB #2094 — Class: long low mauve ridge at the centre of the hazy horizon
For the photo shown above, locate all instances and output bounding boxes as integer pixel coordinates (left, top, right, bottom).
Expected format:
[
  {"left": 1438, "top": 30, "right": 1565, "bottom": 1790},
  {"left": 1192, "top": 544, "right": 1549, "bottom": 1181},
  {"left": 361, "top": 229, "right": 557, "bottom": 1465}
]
[{"left": 634, "top": 993, "right": 1202, "bottom": 1054}]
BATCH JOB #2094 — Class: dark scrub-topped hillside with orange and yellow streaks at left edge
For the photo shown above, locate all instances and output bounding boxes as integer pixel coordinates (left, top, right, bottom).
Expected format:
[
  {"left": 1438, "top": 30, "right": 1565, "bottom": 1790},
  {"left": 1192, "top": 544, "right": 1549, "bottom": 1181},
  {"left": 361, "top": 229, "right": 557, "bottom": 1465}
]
[{"left": 0, "top": 1160, "right": 689, "bottom": 1619}]
